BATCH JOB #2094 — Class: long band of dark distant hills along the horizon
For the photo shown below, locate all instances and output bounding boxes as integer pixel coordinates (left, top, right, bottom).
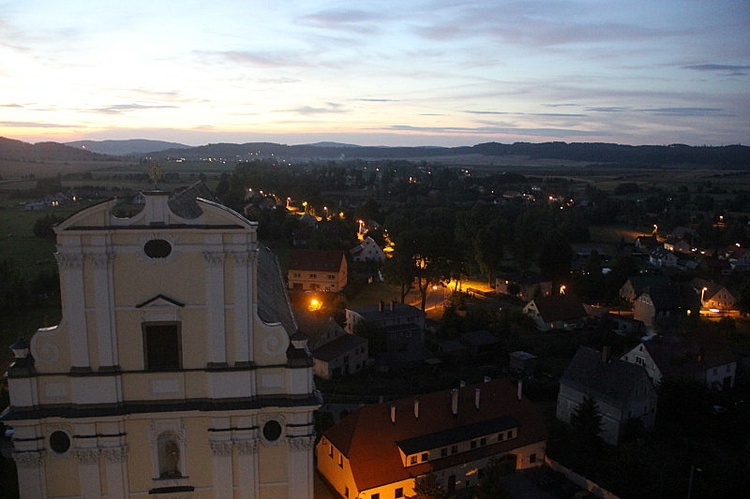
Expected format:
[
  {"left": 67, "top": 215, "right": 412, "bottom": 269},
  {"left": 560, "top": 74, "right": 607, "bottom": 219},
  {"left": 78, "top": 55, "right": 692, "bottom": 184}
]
[{"left": 0, "top": 137, "right": 750, "bottom": 169}]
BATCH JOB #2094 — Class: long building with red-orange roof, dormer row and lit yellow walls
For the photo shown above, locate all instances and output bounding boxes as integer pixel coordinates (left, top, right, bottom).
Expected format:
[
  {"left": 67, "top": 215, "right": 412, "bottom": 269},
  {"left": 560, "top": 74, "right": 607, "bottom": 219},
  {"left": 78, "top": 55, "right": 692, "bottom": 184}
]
[{"left": 316, "top": 380, "right": 547, "bottom": 499}]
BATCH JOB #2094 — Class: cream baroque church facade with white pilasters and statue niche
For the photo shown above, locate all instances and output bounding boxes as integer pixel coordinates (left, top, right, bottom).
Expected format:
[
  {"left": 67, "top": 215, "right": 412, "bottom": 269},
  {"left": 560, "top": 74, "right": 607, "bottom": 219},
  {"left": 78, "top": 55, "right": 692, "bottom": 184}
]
[{"left": 2, "top": 191, "right": 320, "bottom": 498}]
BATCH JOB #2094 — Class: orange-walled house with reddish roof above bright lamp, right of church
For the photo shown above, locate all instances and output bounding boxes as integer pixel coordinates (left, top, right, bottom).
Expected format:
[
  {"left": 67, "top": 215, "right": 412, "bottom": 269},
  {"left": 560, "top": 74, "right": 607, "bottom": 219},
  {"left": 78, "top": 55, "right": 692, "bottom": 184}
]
[{"left": 287, "top": 249, "right": 347, "bottom": 293}]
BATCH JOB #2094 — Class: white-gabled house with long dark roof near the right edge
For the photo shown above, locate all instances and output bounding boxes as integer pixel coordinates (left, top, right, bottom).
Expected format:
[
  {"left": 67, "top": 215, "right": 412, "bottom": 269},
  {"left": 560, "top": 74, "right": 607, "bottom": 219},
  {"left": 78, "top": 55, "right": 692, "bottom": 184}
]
[{"left": 621, "top": 334, "right": 737, "bottom": 391}]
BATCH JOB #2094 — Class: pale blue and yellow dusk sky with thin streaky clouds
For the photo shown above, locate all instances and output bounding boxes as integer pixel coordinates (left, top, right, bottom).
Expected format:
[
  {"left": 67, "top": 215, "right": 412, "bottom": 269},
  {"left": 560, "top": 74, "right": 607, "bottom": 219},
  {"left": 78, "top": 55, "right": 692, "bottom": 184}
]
[{"left": 0, "top": 0, "right": 750, "bottom": 146}]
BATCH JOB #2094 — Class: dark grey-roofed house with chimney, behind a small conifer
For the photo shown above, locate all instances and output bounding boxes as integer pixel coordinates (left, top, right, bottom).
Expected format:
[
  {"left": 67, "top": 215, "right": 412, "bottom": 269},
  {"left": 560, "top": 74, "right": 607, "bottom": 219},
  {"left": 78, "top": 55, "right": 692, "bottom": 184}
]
[{"left": 556, "top": 347, "right": 657, "bottom": 445}]
